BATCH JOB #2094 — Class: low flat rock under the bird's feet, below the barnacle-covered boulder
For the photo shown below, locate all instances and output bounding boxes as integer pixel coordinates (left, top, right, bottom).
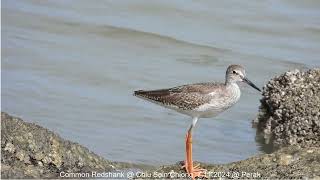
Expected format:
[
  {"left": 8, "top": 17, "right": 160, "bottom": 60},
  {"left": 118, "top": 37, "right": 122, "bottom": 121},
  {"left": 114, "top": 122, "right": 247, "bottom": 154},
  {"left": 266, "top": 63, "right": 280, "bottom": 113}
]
[{"left": 145, "top": 146, "right": 320, "bottom": 179}]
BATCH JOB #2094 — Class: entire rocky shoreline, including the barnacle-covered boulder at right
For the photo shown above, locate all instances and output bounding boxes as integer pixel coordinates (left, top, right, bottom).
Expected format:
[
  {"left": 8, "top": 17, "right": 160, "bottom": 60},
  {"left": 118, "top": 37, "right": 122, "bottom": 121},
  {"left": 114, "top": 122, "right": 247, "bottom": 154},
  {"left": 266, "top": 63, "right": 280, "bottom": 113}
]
[{"left": 1, "top": 69, "right": 320, "bottom": 179}]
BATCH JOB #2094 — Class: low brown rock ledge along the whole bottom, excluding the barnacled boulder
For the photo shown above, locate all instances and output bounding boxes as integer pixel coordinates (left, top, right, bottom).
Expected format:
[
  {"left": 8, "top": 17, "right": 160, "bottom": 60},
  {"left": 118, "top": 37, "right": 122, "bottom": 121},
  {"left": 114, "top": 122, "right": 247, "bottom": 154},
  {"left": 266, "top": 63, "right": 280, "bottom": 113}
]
[{"left": 1, "top": 113, "right": 320, "bottom": 179}]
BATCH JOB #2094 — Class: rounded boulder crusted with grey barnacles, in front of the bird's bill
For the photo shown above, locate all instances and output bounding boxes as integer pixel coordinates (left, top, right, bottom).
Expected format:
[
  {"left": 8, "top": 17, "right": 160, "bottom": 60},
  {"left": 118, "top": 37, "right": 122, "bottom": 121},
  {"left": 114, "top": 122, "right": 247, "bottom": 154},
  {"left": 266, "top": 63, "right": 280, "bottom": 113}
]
[{"left": 257, "top": 69, "right": 320, "bottom": 147}]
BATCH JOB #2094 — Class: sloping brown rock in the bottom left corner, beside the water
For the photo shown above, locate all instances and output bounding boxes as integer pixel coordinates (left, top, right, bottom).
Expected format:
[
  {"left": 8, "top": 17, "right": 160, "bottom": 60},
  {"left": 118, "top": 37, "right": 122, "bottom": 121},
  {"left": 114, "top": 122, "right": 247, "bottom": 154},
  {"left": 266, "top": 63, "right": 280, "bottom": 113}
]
[{"left": 1, "top": 113, "right": 139, "bottom": 179}]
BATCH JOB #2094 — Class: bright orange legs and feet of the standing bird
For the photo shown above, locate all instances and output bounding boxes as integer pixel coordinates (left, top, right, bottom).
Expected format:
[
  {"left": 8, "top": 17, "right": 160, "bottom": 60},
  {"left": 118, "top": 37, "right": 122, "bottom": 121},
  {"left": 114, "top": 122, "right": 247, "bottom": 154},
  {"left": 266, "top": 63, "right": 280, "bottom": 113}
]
[{"left": 183, "top": 128, "right": 206, "bottom": 179}]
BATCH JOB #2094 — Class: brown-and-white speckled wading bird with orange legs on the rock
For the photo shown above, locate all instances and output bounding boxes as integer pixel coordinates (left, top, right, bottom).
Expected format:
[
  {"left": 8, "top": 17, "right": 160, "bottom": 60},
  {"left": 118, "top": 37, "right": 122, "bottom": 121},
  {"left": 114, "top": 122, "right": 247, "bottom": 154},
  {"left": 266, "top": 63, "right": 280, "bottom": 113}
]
[{"left": 133, "top": 65, "right": 261, "bottom": 179}]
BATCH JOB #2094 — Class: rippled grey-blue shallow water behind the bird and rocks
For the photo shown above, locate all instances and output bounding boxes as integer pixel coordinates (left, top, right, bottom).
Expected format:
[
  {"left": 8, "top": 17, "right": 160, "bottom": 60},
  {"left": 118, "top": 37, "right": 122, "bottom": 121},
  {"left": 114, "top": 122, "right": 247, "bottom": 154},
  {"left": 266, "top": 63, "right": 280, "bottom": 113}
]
[{"left": 2, "top": 0, "right": 320, "bottom": 165}]
